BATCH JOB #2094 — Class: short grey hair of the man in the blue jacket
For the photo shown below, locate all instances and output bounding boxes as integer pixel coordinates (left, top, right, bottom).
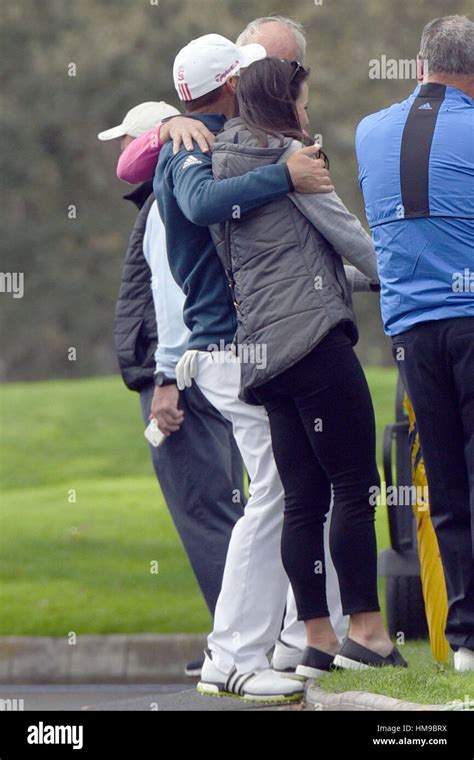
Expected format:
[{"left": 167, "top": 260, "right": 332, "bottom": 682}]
[{"left": 420, "top": 16, "right": 474, "bottom": 76}]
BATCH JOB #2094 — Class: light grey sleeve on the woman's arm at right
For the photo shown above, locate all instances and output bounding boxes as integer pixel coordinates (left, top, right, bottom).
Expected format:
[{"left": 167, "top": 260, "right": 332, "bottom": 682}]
[{"left": 281, "top": 143, "right": 379, "bottom": 283}]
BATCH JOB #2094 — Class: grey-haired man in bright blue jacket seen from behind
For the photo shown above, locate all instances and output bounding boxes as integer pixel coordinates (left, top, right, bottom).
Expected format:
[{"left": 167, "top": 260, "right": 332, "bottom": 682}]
[{"left": 356, "top": 16, "right": 474, "bottom": 671}]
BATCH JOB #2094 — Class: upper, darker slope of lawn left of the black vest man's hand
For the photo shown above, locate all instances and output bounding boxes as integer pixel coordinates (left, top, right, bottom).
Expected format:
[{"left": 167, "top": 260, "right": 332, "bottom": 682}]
[{"left": 0, "top": 377, "right": 159, "bottom": 489}]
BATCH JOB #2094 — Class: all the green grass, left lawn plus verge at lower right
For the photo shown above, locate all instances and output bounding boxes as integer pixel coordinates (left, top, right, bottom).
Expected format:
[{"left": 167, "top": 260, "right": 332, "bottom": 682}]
[{"left": 0, "top": 368, "right": 474, "bottom": 702}]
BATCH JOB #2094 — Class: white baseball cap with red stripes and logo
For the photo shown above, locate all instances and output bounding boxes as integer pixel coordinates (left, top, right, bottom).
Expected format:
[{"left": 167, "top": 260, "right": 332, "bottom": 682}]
[{"left": 173, "top": 34, "right": 267, "bottom": 101}]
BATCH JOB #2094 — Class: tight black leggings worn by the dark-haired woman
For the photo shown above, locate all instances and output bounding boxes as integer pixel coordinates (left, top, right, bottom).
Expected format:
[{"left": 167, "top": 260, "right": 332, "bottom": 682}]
[{"left": 257, "top": 327, "right": 380, "bottom": 620}]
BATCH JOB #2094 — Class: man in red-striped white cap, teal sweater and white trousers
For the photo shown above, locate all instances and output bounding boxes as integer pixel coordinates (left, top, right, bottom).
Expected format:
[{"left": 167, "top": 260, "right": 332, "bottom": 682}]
[{"left": 154, "top": 34, "right": 337, "bottom": 702}]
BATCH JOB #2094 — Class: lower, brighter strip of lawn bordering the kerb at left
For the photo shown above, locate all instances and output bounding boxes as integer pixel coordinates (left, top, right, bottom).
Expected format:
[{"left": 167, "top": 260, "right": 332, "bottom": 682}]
[{"left": 0, "top": 480, "right": 210, "bottom": 636}]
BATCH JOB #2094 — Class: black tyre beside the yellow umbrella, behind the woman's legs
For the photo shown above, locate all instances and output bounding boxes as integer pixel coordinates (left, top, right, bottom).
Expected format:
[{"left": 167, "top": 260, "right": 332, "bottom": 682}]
[{"left": 385, "top": 575, "right": 428, "bottom": 640}]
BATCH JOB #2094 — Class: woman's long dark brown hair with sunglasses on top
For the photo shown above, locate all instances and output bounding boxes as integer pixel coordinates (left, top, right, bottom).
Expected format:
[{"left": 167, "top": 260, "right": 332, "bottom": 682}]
[{"left": 237, "top": 58, "right": 328, "bottom": 163}]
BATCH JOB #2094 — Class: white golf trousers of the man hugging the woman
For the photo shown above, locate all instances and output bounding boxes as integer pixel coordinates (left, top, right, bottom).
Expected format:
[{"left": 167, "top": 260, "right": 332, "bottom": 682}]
[{"left": 196, "top": 351, "right": 347, "bottom": 673}]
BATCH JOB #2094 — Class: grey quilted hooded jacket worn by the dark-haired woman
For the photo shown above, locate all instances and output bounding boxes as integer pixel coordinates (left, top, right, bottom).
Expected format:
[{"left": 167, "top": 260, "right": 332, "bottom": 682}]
[{"left": 211, "top": 118, "right": 378, "bottom": 403}]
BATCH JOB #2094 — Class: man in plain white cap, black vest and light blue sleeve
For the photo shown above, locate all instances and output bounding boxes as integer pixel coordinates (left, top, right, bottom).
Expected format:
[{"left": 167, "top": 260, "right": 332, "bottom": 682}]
[{"left": 98, "top": 102, "right": 243, "bottom": 676}]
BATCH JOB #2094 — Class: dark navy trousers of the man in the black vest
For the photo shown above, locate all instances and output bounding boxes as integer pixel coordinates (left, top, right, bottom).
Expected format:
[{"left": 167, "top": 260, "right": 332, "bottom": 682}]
[{"left": 140, "top": 383, "right": 245, "bottom": 615}]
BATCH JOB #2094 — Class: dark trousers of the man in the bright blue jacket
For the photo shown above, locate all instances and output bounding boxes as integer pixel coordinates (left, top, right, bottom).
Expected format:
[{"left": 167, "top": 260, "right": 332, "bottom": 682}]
[{"left": 392, "top": 317, "right": 474, "bottom": 650}]
